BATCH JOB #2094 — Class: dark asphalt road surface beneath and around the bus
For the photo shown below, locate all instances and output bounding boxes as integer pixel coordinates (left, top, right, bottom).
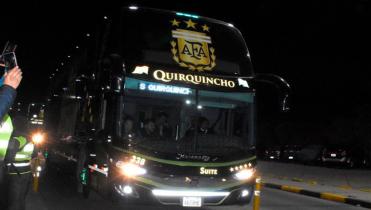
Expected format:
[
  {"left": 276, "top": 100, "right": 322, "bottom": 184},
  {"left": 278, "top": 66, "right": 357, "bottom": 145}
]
[{"left": 27, "top": 167, "right": 365, "bottom": 210}]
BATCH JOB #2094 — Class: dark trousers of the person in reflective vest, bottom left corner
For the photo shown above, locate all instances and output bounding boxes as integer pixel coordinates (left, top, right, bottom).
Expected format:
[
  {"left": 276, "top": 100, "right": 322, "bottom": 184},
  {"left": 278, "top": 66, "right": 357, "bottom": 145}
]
[{"left": 0, "top": 173, "right": 32, "bottom": 210}]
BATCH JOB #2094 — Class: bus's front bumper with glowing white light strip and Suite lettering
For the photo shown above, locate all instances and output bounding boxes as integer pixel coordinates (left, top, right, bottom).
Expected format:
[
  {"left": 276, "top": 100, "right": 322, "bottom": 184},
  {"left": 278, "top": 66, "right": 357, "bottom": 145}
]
[{"left": 108, "top": 152, "right": 255, "bottom": 207}]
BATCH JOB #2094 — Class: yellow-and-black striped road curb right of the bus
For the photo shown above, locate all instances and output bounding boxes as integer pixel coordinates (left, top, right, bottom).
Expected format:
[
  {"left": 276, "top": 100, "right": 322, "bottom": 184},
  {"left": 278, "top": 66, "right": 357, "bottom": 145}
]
[{"left": 263, "top": 183, "right": 371, "bottom": 209}]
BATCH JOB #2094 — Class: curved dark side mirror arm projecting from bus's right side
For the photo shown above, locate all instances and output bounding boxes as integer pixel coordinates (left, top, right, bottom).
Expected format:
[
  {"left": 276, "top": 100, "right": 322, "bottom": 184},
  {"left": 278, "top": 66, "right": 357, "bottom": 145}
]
[{"left": 252, "top": 74, "right": 291, "bottom": 112}]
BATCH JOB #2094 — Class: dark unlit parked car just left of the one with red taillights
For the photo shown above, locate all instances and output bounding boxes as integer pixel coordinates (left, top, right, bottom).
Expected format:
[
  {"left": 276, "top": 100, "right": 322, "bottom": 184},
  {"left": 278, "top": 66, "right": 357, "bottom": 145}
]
[{"left": 296, "top": 144, "right": 324, "bottom": 164}]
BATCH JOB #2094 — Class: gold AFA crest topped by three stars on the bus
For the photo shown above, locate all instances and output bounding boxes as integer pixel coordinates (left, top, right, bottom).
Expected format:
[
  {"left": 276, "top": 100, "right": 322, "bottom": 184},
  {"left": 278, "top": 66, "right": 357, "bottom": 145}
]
[{"left": 170, "top": 19, "right": 216, "bottom": 72}]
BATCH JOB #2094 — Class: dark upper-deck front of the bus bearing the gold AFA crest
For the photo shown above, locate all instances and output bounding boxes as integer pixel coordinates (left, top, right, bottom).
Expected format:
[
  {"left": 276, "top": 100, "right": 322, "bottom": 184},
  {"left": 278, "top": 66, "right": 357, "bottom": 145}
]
[{"left": 111, "top": 7, "right": 253, "bottom": 76}]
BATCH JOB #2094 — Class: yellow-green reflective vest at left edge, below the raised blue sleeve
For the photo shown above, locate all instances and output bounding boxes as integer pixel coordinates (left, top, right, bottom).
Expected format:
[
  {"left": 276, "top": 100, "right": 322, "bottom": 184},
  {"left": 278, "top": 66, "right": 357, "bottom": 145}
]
[{"left": 0, "top": 115, "right": 13, "bottom": 161}]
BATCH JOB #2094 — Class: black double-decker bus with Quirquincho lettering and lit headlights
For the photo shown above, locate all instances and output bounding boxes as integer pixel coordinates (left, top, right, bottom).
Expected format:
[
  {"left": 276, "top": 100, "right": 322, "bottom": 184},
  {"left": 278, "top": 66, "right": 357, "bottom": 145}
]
[{"left": 46, "top": 6, "right": 289, "bottom": 207}]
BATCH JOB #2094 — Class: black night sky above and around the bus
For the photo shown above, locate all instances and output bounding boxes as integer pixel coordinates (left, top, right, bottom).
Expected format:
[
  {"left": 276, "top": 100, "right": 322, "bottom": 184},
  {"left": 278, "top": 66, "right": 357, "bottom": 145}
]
[{"left": 0, "top": 0, "right": 371, "bottom": 121}]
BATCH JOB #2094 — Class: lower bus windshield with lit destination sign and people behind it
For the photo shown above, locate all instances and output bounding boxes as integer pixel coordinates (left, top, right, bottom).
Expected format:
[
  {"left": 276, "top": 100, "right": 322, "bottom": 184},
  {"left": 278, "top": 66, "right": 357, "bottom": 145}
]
[{"left": 114, "top": 78, "right": 253, "bottom": 158}]
